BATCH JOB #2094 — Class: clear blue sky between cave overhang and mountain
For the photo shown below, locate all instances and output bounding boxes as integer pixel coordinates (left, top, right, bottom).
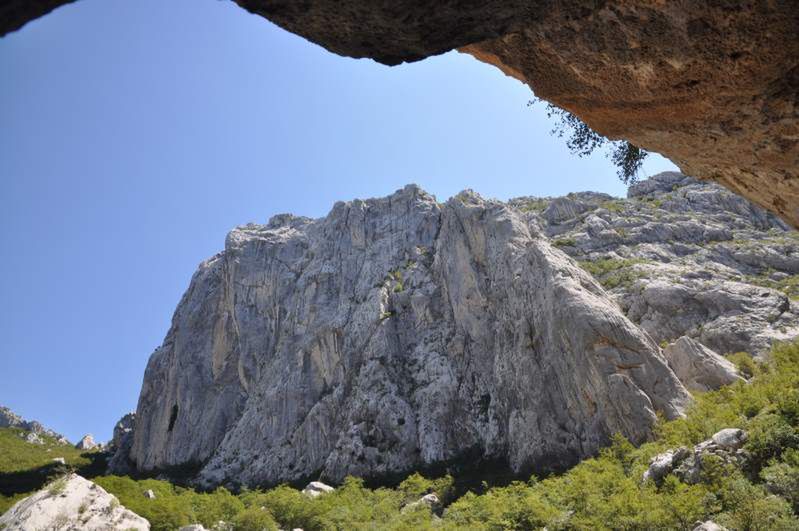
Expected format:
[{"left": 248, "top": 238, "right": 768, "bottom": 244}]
[{"left": 0, "top": 0, "right": 673, "bottom": 440}]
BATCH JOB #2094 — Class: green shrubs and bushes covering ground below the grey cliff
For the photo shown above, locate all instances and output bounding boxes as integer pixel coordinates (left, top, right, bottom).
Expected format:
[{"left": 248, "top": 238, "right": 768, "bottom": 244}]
[{"left": 0, "top": 343, "right": 799, "bottom": 531}]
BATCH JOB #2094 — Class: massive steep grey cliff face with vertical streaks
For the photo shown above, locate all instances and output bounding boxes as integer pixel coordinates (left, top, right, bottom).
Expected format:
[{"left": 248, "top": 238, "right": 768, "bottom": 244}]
[{"left": 131, "top": 186, "right": 689, "bottom": 485}]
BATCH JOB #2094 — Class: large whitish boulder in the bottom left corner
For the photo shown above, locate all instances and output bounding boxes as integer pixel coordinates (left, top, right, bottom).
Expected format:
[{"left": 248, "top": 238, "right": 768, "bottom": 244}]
[{"left": 0, "top": 474, "right": 150, "bottom": 531}]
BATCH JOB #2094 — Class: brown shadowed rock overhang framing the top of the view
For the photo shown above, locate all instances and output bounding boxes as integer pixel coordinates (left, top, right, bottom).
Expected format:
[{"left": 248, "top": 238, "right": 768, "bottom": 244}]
[{"left": 0, "top": 0, "right": 799, "bottom": 227}]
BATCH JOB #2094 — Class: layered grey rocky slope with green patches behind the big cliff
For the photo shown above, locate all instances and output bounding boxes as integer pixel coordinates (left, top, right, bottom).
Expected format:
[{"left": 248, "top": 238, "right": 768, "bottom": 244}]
[{"left": 510, "top": 172, "right": 799, "bottom": 355}]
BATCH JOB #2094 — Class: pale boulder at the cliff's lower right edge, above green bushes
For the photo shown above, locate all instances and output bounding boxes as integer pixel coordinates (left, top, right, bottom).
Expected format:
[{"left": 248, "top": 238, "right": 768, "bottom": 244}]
[{"left": 663, "top": 336, "right": 743, "bottom": 391}]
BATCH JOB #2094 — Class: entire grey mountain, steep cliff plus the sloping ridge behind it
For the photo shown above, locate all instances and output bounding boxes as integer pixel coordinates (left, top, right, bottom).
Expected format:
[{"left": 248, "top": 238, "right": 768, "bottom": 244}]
[{"left": 112, "top": 173, "right": 799, "bottom": 485}]
